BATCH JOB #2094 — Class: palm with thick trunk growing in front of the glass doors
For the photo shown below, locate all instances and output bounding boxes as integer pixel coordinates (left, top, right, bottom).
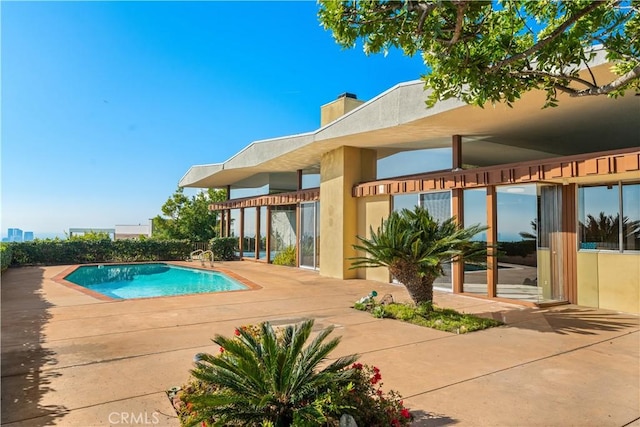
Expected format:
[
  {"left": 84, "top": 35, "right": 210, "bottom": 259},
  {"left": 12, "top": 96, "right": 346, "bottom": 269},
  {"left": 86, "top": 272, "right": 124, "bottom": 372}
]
[{"left": 352, "top": 206, "right": 486, "bottom": 304}]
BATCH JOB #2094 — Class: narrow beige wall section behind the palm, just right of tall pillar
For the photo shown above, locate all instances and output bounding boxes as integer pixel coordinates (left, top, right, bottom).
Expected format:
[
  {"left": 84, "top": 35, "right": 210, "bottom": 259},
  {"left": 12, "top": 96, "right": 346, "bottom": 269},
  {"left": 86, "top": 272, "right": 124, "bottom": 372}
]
[{"left": 357, "top": 195, "right": 391, "bottom": 283}]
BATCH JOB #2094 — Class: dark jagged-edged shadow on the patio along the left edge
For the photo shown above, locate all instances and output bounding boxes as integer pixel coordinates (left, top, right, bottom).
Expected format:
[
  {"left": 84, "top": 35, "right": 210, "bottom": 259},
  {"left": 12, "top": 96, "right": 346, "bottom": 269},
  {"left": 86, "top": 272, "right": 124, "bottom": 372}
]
[{"left": 0, "top": 268, "right": 68, "bottom": 425}]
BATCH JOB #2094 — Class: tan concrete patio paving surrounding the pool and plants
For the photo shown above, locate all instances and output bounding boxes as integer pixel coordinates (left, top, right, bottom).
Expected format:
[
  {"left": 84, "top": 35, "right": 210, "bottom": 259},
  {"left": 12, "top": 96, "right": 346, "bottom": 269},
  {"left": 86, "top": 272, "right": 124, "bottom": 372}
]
[{"left": 1, "top": 262, "right": 640, "bottom": 426}]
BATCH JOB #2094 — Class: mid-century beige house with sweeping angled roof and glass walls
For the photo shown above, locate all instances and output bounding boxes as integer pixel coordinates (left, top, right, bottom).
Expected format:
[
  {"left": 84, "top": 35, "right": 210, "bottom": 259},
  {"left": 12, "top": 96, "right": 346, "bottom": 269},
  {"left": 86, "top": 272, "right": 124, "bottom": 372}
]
[{"left": 180, "top": 57, "right": 640, "bottom": 313}]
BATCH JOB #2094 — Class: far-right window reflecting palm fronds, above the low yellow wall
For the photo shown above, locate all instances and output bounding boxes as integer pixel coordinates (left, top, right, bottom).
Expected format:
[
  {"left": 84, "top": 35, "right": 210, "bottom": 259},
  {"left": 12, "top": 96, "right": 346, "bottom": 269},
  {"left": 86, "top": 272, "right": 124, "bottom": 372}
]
[{"left": 578, "top": 183, "right": 640, "bottom": 252}]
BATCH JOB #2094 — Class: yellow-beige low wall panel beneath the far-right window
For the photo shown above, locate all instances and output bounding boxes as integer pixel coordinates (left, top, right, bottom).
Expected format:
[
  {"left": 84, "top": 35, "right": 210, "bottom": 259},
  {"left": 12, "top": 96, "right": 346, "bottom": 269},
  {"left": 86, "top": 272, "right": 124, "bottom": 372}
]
[{"left": 578, "top": 252, "right": 640, "bottom": 313}]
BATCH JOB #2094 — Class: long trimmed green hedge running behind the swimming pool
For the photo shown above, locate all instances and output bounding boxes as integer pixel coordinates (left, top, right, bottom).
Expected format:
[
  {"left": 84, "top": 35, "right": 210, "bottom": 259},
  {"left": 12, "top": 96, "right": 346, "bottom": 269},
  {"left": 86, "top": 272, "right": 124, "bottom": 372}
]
[{"left": 3, "top": 239, "right": 191, "bottom": 266}]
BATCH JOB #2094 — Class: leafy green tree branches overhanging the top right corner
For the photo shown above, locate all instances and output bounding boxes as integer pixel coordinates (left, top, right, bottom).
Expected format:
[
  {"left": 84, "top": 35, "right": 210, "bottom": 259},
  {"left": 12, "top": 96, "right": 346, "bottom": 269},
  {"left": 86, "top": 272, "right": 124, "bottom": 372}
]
[{"left": 318, "top": 0, "right": 640, "bottom": 107}]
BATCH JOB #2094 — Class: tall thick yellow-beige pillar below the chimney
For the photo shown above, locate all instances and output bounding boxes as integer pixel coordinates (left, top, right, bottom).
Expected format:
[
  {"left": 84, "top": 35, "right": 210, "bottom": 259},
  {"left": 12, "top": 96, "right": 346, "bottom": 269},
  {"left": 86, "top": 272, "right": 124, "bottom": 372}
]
[{"left": 320, "top": 146, "right": 376, "bottom": 279}]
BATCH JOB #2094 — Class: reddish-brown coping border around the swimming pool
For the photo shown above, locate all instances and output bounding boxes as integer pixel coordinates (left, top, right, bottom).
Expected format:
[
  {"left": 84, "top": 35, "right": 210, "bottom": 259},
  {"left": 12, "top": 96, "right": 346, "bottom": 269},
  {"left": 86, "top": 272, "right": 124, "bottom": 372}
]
[{"left": 52, "top": 261, "right": 262, "bottom": 302}]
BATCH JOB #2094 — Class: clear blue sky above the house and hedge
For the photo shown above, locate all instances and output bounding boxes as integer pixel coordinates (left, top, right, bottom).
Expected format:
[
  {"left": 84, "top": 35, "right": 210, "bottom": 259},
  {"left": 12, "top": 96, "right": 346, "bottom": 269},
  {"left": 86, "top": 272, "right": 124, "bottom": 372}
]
[{"left": 0, "top": 2, "right": 425, "bottom": 237}]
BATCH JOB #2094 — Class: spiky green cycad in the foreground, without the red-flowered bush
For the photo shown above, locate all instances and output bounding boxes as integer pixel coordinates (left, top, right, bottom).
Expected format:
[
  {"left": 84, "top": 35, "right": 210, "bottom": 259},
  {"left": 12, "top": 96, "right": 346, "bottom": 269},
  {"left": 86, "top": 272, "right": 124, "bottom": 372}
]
[{"left": 191, "top": 320, "right": 357, "bottom": 427}]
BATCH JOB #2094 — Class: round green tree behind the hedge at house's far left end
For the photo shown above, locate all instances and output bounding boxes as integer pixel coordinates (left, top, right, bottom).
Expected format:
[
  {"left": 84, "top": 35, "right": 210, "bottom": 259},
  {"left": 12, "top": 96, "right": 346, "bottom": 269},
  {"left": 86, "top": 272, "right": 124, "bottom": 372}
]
[{"left": 153, "top": 187, "right": 227, "bottom": 242}]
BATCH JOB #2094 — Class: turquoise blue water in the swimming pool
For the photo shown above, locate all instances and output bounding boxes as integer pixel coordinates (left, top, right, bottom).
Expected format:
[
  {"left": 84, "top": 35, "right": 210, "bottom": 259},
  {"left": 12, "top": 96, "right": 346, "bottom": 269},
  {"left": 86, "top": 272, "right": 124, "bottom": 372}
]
[{"left": 65, "top": 263, "right": 247, "bottom": 299}]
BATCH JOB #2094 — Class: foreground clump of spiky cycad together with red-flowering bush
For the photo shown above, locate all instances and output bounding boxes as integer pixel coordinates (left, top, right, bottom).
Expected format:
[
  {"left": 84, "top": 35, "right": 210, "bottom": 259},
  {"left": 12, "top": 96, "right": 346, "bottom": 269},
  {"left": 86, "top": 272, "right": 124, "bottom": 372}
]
[{"left": 178, "top": 320, "right": 413, "bottom": 427}]
